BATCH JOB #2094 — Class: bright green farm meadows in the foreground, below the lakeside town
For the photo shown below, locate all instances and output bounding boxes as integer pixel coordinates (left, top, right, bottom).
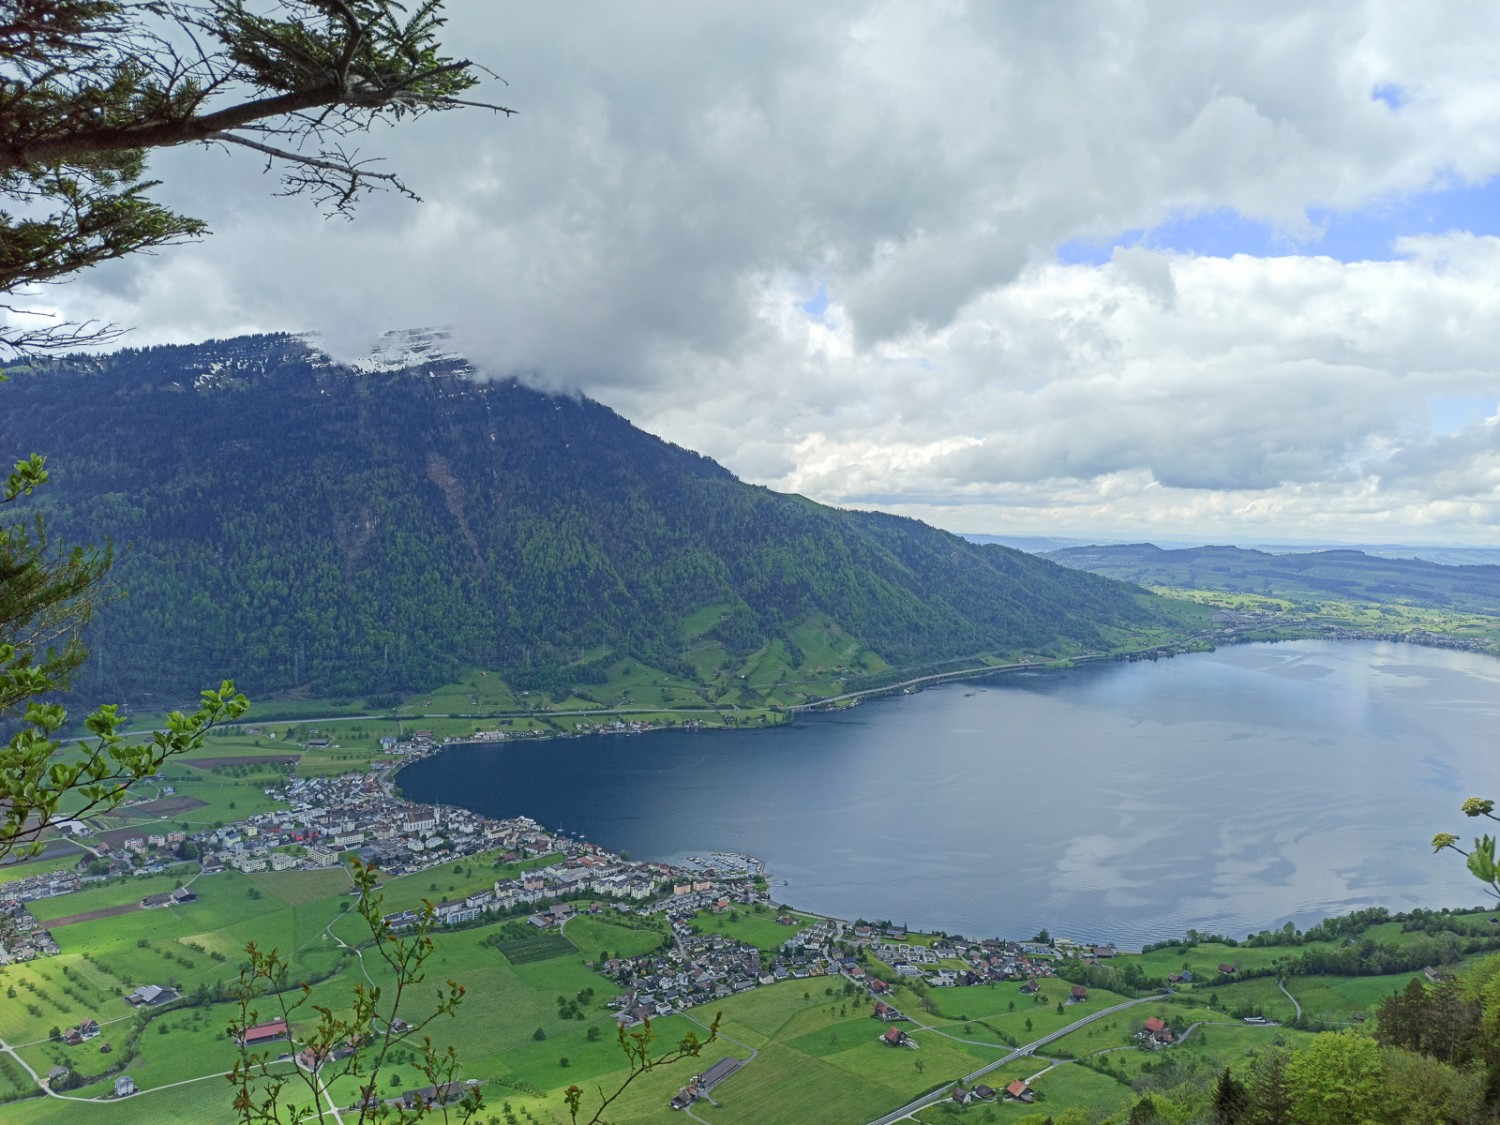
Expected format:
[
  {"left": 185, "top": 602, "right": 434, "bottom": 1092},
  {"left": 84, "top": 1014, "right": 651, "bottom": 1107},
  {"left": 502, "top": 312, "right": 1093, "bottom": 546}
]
[{"left": 0, "top": 804, "right": 1496, "bottom": 1125}]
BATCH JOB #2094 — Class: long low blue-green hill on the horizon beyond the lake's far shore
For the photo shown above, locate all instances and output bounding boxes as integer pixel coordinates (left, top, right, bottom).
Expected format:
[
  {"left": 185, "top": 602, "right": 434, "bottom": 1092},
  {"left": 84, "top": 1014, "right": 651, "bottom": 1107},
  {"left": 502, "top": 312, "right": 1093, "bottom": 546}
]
[{"left": 1046, "top": 543, "right": 1500, "bottom": 615}]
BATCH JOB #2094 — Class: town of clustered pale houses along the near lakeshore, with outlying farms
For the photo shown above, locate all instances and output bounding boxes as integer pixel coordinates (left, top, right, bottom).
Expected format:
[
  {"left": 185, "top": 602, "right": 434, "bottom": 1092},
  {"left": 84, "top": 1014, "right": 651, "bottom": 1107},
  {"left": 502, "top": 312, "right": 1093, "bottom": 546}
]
[{"left": 0, "top": 738, "right": 1194, "bottom": 1107}]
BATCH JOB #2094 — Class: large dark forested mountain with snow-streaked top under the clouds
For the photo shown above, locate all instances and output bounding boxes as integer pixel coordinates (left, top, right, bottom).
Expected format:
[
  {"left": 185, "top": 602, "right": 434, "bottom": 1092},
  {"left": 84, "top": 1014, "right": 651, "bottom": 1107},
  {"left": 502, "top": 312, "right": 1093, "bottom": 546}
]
[{"left": 0, "top": 336, "right": 1182, "bottom": 696}]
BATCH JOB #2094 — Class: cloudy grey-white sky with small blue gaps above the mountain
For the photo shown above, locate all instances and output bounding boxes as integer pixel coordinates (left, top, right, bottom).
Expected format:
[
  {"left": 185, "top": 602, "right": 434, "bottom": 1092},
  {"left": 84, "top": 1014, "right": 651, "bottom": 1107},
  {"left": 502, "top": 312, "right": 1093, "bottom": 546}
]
[{"left": 32, "top": 0, "right": 1500, "bottom": 545}]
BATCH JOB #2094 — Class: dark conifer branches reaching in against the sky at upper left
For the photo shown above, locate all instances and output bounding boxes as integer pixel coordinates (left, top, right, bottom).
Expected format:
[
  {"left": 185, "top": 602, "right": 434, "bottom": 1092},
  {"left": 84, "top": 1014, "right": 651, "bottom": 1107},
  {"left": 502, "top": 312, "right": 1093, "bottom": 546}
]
[{"left": 0, "top": 0, "right": 512, "bottom": 351}]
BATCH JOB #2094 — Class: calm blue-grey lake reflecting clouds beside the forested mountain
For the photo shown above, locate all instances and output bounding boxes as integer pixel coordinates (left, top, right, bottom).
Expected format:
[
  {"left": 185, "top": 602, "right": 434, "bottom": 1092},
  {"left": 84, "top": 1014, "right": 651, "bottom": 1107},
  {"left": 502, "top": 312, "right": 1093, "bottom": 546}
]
[{"left": 401, "top": 641, "right": 1500, "bottom": 947}]
